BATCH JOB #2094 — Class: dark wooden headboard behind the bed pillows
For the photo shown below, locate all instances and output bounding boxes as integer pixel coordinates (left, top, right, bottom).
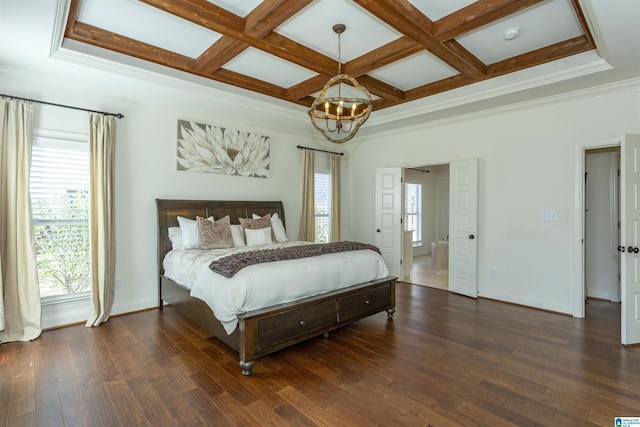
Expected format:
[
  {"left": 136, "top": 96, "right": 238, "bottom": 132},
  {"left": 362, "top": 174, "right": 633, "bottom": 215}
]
[{"left": 156, "top": 199, "right": 285, "bottom": 276}]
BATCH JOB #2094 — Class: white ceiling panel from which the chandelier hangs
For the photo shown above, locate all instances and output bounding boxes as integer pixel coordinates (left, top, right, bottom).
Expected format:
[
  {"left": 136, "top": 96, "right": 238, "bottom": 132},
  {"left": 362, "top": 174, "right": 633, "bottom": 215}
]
[{"left": 276, "top": 0, "right": 400, "bottom": 63}]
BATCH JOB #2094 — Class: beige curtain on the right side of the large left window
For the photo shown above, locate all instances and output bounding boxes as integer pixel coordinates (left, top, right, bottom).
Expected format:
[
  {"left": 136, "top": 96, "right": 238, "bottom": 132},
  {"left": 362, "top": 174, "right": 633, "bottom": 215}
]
[{"left": 86, "top": 113, "right": 116, "bottom": 327}]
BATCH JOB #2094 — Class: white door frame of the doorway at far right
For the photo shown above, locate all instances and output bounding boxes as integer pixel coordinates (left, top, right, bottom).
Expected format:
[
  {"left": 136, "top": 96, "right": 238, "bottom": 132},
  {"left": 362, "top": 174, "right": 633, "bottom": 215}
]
[{"left": 573, "top": 137, "right": 622, "bottom": 318}]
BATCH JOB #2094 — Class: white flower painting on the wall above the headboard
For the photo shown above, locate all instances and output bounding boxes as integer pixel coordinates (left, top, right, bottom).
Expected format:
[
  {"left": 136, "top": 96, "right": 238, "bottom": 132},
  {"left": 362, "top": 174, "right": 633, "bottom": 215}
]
[{"left": 177, "top": 120, "right": 269, "bottom": 178}]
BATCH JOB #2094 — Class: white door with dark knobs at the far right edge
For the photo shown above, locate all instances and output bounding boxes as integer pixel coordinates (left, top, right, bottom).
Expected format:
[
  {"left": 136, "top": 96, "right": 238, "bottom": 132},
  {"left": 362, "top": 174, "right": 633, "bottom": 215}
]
[{"left": 620, "top": 135, "right": 640, "bottom": 345}]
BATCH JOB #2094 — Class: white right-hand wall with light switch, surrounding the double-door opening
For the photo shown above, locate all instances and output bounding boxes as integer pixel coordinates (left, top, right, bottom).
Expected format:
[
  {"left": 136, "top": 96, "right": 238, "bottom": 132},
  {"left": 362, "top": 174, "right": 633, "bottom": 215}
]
[{"left": 344, "top": 80, "right": 640, "bottom": 313}]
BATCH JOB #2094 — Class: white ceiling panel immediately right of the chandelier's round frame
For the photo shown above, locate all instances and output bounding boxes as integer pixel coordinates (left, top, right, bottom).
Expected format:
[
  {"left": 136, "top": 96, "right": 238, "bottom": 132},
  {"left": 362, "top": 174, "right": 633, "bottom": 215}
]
[{"left": 369, "top": 52, "right": 458, "bottom": 90}]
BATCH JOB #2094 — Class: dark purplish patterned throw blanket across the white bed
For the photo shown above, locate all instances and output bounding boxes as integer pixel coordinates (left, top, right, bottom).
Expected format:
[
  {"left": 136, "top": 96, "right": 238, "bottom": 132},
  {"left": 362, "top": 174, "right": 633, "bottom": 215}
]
[{"left": 209, "top": 242, "right": 380, "bottom": 277}]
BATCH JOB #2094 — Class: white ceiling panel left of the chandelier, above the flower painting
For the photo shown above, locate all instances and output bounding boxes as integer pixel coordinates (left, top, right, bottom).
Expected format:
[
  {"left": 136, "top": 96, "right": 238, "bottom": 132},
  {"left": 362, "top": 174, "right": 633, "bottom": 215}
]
[{"left": 224, "top": 48, "right": 316, "bottom": 88}]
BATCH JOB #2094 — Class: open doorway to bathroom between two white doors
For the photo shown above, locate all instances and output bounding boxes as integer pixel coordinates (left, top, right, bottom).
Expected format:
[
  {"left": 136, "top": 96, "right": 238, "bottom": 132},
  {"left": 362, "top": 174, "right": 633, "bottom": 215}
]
[{"left": 403, "top": 164, "right": 449, "bottom": 290}]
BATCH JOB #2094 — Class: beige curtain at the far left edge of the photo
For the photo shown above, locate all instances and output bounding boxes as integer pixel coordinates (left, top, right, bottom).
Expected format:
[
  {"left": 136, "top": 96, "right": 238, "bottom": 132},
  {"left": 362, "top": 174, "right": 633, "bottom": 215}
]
[{"left": 0, "top": 99, "right": 42, "bottom": 343}]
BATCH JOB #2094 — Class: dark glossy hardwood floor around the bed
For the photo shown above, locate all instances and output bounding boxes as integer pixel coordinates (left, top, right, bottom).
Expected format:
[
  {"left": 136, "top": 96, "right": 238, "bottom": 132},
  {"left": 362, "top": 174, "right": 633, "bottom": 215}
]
[{"left": 0, "top": 283, "right": 640, "bottom": 427}]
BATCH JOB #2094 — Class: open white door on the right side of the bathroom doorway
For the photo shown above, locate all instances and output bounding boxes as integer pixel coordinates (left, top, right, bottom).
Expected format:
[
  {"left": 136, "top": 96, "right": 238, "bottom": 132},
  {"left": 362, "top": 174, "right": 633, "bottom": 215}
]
[{"left": 449, "top": 159, "right": 478, "bottom": 298}]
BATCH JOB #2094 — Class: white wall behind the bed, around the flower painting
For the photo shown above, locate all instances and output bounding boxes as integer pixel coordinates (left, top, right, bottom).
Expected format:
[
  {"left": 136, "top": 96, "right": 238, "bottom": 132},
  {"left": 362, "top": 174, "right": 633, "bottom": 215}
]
[{"left": 0, "top": 71, "right": 326, "bottom": 327}]
